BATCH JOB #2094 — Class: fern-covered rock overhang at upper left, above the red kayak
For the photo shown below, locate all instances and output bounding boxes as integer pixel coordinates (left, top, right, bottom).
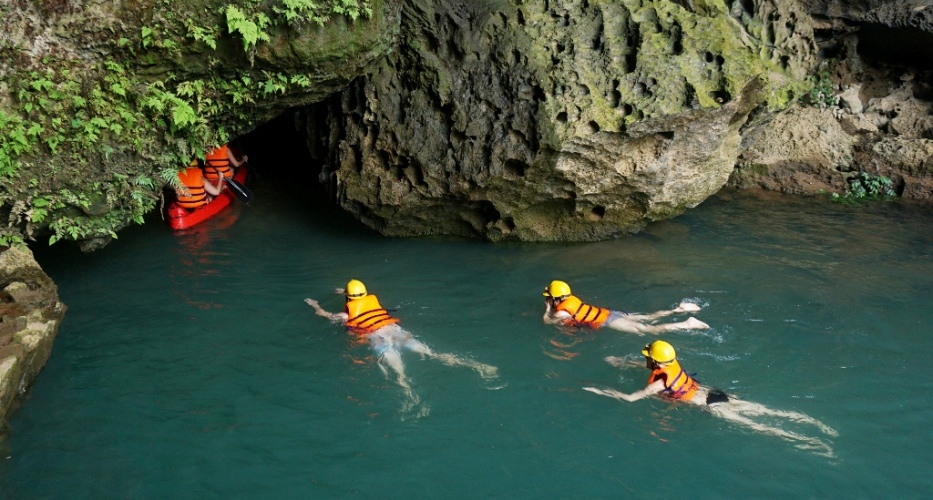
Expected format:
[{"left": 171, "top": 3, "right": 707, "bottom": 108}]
[{"left": 0, "top": 0, "right": 400, "bottom": 248}]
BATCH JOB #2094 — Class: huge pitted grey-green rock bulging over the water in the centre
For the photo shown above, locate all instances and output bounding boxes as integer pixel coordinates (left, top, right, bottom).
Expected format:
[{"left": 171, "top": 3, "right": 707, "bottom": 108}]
[{"left": 309, "top": 0, "right": 817, "bottom": 241}]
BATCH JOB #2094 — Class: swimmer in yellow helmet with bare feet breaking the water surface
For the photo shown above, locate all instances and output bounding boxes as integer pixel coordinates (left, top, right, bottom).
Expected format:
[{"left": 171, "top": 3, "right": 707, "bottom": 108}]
[{"left": 544, "top": 280, "right": 709, "bottom": 335}]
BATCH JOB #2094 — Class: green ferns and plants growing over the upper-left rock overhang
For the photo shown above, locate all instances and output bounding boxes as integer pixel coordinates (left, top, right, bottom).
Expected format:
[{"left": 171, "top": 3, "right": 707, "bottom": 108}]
[{"left": 0, "top": 0, "right": 372, "bottom": 245}]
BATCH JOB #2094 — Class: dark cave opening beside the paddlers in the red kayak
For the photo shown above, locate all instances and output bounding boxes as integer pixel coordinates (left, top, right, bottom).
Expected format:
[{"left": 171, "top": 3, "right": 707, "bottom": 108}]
[{"left": 232, "top": 106, "right": 328, "bottom": 202}]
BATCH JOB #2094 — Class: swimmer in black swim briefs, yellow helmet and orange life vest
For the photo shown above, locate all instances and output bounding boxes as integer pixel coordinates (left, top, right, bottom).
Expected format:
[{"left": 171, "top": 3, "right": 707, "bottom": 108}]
[{"left": 583, "top": 340, "right": 839, "bottom": 457}]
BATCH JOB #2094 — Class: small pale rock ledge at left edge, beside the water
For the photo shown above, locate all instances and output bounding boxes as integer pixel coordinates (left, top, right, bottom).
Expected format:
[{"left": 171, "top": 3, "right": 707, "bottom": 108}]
[{"left": 0, "top": 247, "right": 66, "bottom": 432}]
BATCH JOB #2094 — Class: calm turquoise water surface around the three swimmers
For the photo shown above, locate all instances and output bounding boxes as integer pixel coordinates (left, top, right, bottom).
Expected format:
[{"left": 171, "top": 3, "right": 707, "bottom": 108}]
[{"left": 0, "top": 181, "right": 933, "bottom": 498}]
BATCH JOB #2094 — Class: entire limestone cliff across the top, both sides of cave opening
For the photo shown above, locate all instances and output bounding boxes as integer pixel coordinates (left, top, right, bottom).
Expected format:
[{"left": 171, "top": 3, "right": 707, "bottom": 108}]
[{"left": 0, "top": 0, "right": 933, "bottom": 248}]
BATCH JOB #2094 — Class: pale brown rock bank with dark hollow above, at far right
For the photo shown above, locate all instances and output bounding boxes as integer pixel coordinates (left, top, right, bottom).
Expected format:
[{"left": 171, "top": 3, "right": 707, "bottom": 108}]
[{"left": 729, "top": 0, "right": 933, "bottom": 197}]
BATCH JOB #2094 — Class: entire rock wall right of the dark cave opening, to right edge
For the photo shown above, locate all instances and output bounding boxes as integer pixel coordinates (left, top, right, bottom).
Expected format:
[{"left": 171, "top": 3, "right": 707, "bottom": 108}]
[{"left": 308, "top": 0, "right": 933, "bottom": 241}]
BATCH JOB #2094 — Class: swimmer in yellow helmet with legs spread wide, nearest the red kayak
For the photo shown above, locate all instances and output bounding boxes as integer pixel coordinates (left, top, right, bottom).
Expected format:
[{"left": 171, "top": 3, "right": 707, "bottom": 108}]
[{"left": 305, "top": 279, "right": 498, "bottom": 414}]
